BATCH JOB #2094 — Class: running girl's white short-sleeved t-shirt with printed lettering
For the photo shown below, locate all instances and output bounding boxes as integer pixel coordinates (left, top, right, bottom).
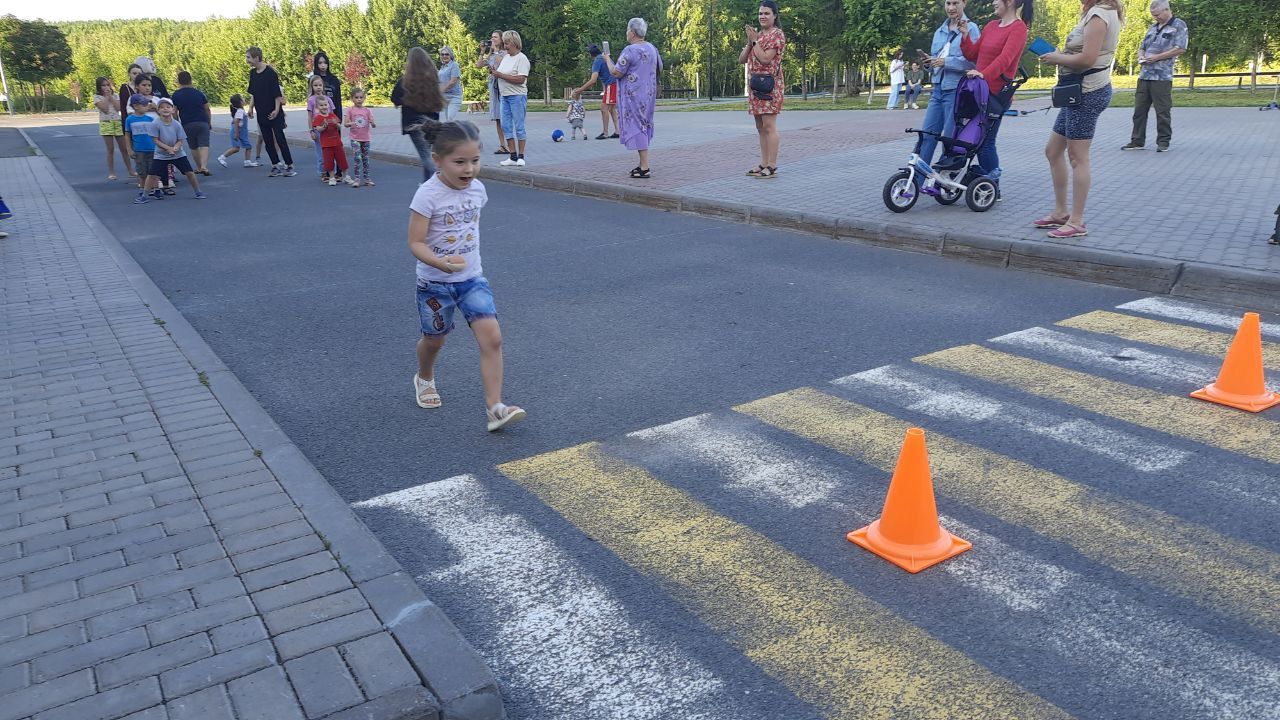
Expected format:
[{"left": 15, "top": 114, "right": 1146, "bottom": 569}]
[{"left": 408, "top": 174, "right": 489, "bottom": 283}]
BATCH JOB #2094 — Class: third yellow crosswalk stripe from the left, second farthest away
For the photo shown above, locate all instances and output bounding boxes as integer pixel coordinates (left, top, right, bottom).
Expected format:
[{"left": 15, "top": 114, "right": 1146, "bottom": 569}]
[{"left": 915, "top": 345, "right": 1280, "bottom": 464}]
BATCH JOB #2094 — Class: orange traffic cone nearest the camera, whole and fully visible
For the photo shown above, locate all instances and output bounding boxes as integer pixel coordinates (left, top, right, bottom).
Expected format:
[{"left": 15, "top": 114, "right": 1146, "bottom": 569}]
[{"left": 846, "top": 428, "right": 973, "bottom": 573}]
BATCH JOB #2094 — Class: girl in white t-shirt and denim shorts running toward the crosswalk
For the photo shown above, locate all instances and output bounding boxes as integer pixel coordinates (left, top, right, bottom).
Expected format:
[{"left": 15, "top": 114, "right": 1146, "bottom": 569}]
[{"left": 408, "top": 120, "right": 526, "bottom": 432}]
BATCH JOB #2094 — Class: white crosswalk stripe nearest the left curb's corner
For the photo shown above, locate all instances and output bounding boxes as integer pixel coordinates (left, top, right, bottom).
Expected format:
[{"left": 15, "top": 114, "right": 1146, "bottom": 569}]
[{"left": 353, "top": 475, "right": 741, "bottom": 720}]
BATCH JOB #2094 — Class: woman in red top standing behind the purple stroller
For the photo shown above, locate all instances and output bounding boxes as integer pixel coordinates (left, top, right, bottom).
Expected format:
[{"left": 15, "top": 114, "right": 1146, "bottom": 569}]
[{"left": 960, "top": 0, "right": 1034, "bottom": 192}]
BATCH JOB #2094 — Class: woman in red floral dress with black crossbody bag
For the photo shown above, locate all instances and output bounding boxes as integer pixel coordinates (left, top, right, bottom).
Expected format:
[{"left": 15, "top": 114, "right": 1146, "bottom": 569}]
[{"left": 737, "top": 0, "right": 787, "bottom": 178}]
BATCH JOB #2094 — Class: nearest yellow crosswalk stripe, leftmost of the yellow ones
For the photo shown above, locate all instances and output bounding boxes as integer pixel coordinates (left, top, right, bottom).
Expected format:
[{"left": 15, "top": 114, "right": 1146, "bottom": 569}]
[{"left": 498, "top": 443, "right": 1068, "bottom": 720}]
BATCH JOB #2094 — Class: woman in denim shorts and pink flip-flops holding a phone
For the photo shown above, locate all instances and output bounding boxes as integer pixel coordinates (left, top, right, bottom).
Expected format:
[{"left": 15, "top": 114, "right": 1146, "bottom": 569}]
[{"left": 1036, "top": 0, "right": 1124, "bottom": 238}]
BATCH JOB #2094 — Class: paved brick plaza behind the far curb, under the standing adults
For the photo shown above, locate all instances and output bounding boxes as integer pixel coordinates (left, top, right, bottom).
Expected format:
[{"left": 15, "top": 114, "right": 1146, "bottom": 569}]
[{"left": 249, "top": 99, "right": 1280, "bottom": 273}]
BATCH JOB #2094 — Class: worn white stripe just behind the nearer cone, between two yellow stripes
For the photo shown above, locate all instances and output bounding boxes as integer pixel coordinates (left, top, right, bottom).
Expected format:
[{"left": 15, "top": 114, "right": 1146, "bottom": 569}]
[{"left": 832, "top": 365, "right": 1192, "bottom": 473}]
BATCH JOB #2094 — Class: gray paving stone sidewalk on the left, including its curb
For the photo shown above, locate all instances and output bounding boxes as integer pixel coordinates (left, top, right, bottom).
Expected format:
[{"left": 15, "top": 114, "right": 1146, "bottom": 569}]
[{"left": 0, "top": 148, "right": 504, "bottom": 720}]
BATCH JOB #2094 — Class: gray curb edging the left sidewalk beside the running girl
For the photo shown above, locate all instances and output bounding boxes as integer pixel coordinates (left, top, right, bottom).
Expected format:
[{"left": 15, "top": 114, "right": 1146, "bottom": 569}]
[{"left": 19, "top": 128, "right": 507, "bottom": 720}]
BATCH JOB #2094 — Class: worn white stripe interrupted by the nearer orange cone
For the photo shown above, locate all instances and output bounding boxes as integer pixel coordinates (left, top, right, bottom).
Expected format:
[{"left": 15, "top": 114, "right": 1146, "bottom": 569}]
[{"left": 630, "top": 415, "right": 1280, "bottom": 720}]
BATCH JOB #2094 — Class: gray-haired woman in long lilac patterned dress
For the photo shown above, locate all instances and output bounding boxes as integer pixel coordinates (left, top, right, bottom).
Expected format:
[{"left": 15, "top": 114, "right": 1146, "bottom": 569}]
[{"left": 604, "top": 18, "right": 662, "bottom": 178}]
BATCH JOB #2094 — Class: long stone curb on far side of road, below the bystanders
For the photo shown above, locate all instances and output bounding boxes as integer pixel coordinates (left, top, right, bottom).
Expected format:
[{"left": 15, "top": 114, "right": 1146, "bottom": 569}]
[{"left": 235, "top": 124, "right": 1280, "bottom": 313}]
